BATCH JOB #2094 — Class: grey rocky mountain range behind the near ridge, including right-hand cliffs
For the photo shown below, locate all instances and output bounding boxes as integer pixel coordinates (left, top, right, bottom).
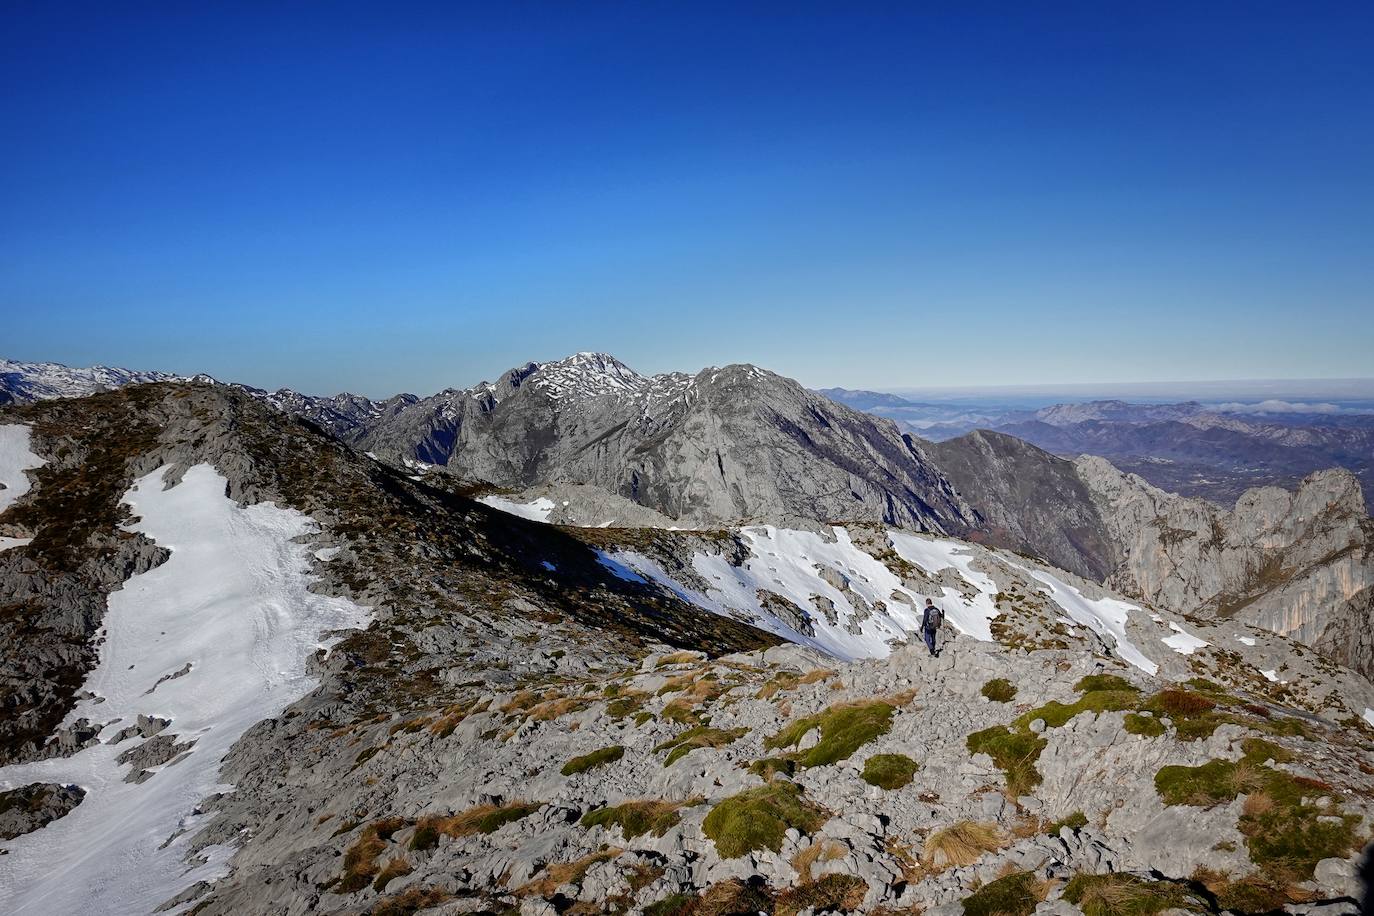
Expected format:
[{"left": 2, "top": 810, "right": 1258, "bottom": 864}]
[{"left": 3, "top": 353, "right": 1374, "bottom": 683}]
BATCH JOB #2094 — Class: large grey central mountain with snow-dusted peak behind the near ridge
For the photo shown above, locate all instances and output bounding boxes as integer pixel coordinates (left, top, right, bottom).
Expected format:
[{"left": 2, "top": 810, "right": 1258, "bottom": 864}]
[{"left": 359, "top": 353, "right": 973, "bottom": 533}]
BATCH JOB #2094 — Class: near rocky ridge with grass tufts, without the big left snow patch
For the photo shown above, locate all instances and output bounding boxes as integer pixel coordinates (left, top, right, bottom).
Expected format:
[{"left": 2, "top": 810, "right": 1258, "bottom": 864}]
[{"left": 0, "top": 386, "right": 1374, "bottom": 916}]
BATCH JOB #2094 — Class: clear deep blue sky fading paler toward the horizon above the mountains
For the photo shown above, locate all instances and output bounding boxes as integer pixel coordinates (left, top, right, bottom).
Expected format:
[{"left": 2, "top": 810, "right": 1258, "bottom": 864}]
[{"left": 0, "top": 1, "right": 1374, "bottom": 394}]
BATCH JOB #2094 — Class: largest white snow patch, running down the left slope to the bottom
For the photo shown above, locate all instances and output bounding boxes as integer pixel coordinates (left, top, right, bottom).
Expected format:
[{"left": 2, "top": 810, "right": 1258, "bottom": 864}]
[{"left": 0, "top": 464, "right": 368, "bottom": 916}]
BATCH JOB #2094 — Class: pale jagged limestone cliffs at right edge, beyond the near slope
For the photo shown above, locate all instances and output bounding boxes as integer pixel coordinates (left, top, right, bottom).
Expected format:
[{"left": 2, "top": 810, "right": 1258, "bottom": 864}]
[{"left": 1076, "top": 457, "right": 1374, "bottom": 674}]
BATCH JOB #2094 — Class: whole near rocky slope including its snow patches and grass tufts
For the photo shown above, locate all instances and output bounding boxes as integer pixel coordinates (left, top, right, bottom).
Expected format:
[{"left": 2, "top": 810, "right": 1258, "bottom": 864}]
[{"left": 0, "top": 379, "right": 1374, "bottom": 916}]
